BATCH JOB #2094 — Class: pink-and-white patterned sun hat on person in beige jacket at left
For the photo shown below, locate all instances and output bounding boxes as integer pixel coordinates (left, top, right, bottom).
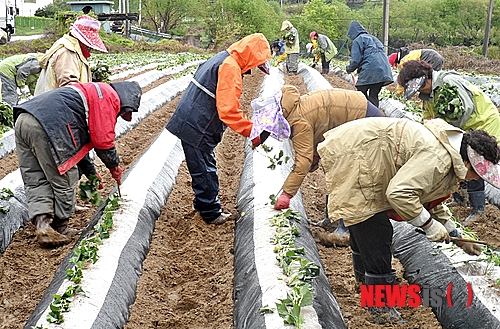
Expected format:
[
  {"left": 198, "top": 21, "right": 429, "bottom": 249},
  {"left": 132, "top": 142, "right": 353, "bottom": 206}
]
[{"left": 69, "top": 15, "right": 108, "bottom": 53}]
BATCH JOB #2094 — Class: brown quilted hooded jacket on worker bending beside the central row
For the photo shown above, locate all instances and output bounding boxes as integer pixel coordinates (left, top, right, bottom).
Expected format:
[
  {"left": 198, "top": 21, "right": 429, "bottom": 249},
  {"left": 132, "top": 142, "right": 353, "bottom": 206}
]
[{"left": 281, "top": 85, "right": 368, "bottom": 195}]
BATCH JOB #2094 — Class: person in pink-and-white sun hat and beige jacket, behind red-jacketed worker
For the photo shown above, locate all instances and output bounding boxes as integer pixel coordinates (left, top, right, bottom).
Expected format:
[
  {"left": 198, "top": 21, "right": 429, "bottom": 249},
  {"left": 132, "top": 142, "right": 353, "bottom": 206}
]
[{"left": 34, "top": 15, "right": 108, "bottom": 195}]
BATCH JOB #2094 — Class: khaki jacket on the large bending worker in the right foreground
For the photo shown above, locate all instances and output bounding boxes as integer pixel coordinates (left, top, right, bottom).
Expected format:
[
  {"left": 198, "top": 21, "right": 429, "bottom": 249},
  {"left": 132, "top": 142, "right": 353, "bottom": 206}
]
[{"left": 318, "top": 118, "right": 467, "bottom": 226}]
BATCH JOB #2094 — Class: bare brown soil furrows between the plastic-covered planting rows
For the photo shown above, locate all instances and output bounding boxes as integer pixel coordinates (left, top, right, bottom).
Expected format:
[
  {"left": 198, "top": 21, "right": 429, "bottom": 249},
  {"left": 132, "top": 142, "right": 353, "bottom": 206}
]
[{"left": 0, "top": 52, "right": 500, "bottom": 329}]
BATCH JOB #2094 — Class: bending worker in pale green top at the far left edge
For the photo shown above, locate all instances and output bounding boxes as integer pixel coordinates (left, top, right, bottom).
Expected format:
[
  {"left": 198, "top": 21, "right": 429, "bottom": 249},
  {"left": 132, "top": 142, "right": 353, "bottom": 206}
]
[{"left": 0, "top": 53, "right": 42, "bottom": 106}]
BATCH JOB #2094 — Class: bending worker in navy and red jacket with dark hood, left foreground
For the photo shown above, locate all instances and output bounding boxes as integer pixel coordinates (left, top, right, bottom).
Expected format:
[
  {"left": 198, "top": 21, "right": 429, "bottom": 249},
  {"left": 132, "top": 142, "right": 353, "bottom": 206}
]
[{"left": 14, "top": 82, "right": 142, "bottom": 247}]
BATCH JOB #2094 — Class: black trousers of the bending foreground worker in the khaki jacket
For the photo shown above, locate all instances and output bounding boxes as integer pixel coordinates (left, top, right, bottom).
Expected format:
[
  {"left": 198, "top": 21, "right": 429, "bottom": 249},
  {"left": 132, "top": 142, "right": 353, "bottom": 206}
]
[{"left": 348, "top": 211, "right": 393, "bottom": 274}]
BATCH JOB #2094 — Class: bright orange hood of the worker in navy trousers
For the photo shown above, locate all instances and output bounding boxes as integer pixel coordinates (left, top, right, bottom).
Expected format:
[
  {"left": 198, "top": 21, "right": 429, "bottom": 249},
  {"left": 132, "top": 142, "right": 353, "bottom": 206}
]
[{"left": 227, "top": 33, "right": 271, "bottom": 73}]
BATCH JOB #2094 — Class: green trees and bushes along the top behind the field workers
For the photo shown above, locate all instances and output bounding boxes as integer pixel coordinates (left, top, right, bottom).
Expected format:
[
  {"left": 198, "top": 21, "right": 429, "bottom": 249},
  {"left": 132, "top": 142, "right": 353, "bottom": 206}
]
[{"left": 36, "top": 0, "right": 500, "bottom": 57}]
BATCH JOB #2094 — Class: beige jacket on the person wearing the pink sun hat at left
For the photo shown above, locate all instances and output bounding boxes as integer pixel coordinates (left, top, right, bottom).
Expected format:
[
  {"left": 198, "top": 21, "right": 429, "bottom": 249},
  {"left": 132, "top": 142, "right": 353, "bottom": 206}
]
[{"left": 35, "top": 34, "right": 92, "bottom": 96}]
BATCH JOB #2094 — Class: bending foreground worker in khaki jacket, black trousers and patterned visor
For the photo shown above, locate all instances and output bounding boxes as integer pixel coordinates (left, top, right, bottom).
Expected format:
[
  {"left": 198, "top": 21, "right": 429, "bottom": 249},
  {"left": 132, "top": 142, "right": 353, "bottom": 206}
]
[{"left": 318, "top": 118, "right": 500, "bottom": 323}]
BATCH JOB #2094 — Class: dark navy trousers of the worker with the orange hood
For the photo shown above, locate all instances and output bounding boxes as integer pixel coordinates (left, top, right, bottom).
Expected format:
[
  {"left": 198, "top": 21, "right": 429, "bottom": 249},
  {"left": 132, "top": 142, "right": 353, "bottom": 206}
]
[{"left": 182, "top": 142, "right": 222, "bottom": 222}]
